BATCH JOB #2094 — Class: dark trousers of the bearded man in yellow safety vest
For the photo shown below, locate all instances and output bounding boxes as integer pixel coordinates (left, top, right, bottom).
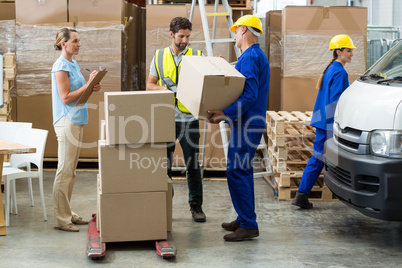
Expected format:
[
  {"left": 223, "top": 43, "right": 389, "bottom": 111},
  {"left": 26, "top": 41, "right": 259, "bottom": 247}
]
[{"left": 167, "top": 120, "right": 202, "bottom": 205}]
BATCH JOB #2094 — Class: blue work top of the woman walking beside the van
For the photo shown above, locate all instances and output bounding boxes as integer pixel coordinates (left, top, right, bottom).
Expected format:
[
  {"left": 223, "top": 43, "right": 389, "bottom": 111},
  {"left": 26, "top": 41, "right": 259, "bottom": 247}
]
[{"left": 310, "top": 61, "right": 349, "bottom": 131}]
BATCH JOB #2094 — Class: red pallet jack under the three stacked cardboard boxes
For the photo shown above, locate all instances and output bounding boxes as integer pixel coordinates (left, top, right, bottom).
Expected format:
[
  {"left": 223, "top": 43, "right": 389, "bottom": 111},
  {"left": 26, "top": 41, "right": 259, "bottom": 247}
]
[{"left": 87, "top": 214, "right": 177, "bottom": 260}]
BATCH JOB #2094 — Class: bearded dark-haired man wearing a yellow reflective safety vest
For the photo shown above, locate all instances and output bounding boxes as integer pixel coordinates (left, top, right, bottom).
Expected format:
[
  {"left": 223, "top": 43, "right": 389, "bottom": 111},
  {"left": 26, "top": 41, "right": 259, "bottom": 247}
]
[{"left": 147, "top": 17, "right": 206, "bottom": 222}]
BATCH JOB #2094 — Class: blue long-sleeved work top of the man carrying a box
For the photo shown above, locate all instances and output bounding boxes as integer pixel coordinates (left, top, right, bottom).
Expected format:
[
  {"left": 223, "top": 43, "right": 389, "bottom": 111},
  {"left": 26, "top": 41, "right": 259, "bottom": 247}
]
[{"left": 223, "top": 44, "right": 270, "bottom": 126}]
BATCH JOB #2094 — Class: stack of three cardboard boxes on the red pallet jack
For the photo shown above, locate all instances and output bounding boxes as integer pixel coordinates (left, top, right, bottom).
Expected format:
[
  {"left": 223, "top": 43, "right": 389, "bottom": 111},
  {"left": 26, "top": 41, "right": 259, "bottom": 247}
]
[{"left": 97, "top": 91, "right": 175, "bottom": 242}]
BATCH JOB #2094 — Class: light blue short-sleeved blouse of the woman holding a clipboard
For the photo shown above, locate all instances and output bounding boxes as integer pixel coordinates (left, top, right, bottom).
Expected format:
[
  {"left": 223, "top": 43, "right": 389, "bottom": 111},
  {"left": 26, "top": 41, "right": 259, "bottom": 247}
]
[{"left": 52, "top": 56, "right": 88, "bottom": 125}]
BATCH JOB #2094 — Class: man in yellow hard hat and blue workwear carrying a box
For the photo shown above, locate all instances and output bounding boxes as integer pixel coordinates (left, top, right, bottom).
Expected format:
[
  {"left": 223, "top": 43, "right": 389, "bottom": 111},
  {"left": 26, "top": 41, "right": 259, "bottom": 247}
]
[{"left": 209, "top": 15, "right": 270, "bottom": 241}]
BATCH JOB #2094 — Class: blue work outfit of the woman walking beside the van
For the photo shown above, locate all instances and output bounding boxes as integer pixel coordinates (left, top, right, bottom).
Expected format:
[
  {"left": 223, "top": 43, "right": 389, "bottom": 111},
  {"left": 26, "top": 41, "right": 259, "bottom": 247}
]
[{"left": 299, "top": 61, "right": 349, "bottom": 194}]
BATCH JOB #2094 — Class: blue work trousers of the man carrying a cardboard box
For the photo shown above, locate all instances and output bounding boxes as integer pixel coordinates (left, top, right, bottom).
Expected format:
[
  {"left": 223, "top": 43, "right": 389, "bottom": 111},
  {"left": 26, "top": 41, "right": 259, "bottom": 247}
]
[{"left": 227, "top": 123, "right": 264, "bottom": 229}]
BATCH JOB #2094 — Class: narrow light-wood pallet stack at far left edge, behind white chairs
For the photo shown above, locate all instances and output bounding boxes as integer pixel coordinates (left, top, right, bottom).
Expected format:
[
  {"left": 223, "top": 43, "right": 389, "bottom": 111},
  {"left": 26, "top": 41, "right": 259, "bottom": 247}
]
[{"left": 0, "top": 53, "right": 15, "bottom": 122}]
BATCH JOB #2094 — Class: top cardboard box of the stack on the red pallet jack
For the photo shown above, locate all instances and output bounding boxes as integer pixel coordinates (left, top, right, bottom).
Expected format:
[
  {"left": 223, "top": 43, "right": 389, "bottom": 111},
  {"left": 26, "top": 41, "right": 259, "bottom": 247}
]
[{"left": 105, "top": 91, "right": 176, "bottom": 145}]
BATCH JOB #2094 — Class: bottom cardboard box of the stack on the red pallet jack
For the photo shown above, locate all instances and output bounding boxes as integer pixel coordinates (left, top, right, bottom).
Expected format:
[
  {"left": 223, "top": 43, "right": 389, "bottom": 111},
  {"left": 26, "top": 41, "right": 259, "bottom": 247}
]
[{"left": 99, "top": 191, "right": 167, "bottom": 242}]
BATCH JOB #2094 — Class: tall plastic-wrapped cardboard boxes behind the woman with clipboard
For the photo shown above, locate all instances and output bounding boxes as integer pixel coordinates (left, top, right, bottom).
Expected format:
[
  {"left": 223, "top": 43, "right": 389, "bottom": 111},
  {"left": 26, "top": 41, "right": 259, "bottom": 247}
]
[{"left": 13, "top": 0, "right": 124, "bottom": 159}]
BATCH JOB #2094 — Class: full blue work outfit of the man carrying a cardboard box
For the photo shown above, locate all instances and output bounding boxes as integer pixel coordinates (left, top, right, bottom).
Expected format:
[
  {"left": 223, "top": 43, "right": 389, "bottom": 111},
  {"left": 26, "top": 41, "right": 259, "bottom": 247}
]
[{"left": 223, "top": 44, "right": 270, "bottom": 229}]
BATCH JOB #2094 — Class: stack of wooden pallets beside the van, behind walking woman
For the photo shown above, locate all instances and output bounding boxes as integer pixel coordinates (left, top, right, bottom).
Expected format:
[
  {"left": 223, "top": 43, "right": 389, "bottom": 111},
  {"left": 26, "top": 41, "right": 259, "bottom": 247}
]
[{"left": 267, "top": 111, "right": 333, "bottom": 200}]
